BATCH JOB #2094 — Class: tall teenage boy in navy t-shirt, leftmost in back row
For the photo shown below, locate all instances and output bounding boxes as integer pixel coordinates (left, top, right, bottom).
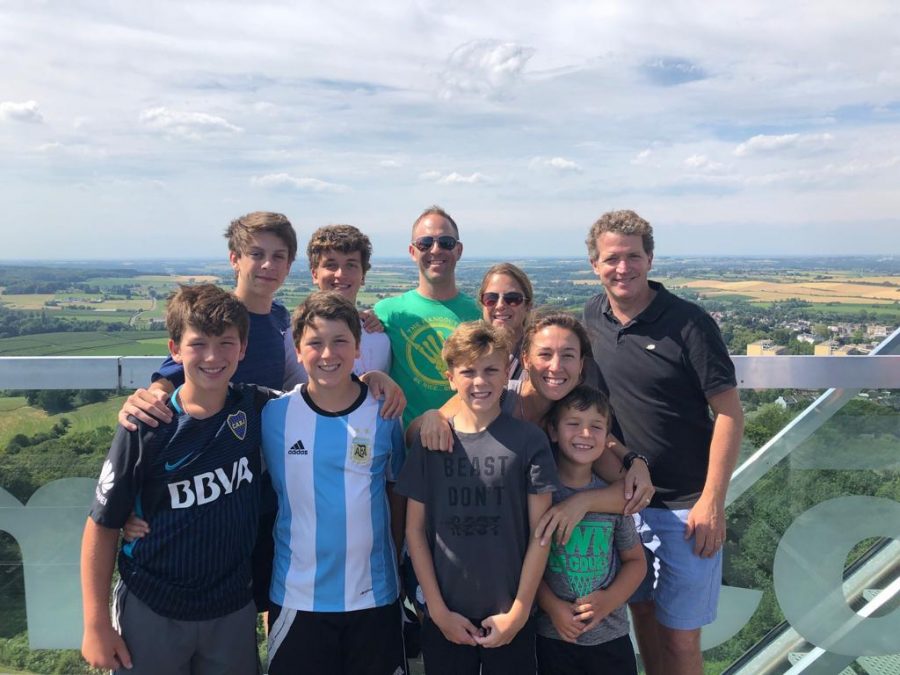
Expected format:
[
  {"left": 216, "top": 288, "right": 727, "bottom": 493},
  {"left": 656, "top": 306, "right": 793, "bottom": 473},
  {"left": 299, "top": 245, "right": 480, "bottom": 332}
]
[{"left": 119, "top": 211, "right": 405, "bottom": 430}]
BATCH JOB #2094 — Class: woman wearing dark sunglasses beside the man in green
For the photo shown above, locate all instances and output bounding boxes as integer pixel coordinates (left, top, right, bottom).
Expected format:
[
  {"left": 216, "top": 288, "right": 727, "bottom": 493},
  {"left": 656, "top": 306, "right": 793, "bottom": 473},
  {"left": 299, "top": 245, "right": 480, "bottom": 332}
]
[{"left": 478, "top": 263, "right": 534, "bottom": 380}]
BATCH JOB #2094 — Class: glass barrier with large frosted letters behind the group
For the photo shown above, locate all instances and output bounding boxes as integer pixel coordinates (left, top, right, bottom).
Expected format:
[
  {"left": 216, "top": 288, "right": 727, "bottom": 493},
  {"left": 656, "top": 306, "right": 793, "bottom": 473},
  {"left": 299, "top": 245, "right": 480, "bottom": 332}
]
[{"left": 0, "top": 357, "right": 900, "bottom": 674}]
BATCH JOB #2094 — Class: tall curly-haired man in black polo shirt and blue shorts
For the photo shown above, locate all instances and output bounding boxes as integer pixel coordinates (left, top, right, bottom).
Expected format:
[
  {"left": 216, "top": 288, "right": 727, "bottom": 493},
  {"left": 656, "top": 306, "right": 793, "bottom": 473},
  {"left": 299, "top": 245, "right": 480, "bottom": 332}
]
[{"left": 584, "top": 211, "right": 744, "bottom": 675}]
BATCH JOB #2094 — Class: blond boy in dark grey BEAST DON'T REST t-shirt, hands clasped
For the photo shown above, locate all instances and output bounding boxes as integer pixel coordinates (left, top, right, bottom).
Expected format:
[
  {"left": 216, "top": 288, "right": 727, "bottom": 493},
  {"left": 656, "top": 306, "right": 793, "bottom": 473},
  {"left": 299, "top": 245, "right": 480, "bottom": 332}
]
[{"left": 397, "top": 321, "right": 556, "bottom": 675}]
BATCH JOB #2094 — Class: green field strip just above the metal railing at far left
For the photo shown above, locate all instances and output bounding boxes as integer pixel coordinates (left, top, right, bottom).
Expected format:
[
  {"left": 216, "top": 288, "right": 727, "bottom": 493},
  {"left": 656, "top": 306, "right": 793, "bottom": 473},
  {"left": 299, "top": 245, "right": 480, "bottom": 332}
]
[{"left": 0, "top": 331, "right": 168, "bottom": 356}]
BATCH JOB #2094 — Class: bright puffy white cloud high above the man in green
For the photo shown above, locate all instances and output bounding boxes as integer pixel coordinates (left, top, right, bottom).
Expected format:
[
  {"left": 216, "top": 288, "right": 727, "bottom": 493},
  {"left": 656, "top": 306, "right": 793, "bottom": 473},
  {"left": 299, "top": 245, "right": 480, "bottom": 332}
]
[{"left": 441, "top": 40, "right": 535, "bottom": 98}]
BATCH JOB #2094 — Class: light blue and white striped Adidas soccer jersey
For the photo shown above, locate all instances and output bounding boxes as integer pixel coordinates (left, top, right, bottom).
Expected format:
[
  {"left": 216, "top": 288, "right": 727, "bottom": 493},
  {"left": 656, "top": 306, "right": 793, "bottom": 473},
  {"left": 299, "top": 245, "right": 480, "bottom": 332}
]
[{"left": 262, "top": 384, "right": 405, "bottom": 612}]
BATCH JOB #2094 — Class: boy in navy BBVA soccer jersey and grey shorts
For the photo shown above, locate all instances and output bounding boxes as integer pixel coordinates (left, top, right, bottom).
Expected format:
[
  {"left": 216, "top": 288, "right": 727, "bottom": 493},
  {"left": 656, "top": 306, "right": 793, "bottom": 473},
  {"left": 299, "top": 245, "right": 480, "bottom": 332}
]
[{"left": 81, "top": 284, "right": 271, "bottom": 674}]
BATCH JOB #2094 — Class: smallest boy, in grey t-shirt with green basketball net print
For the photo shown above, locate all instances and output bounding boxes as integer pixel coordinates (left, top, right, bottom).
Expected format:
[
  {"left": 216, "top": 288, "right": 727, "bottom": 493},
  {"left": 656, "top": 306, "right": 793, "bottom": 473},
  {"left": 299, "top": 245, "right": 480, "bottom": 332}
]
[{"left": 537, "top": 385, "right": 647, "bottom": 675}]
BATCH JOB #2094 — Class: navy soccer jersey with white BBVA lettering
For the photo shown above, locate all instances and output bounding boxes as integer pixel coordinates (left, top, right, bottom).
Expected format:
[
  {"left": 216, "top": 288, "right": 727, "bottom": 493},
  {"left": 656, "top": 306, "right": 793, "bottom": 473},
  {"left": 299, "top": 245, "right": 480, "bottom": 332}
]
[{"left": 91, "top": 385, "right": 275, "bottom": 621}]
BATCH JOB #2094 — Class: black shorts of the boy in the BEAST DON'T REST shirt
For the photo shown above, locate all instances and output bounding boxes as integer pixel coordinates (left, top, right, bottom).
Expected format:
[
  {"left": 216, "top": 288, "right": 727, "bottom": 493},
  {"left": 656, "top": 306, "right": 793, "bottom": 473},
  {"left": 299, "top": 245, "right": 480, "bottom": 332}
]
[{"left": 422, "top": 617, "right": 537, "bottom": 675}]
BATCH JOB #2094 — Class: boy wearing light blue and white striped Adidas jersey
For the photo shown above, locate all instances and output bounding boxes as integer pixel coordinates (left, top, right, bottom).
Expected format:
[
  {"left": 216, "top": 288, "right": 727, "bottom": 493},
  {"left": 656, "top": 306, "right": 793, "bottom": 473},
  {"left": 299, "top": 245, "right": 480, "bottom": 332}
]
[{"left": 263, "top": 292, "right": 405, "bottom": 675}]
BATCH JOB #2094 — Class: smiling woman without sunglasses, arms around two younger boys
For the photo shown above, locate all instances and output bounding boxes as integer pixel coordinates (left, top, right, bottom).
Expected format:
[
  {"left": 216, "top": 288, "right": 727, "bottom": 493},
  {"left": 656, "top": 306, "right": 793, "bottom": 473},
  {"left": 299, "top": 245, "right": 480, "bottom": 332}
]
[{"left": 406, "top": 312, "right": 655, "bottom": 543}]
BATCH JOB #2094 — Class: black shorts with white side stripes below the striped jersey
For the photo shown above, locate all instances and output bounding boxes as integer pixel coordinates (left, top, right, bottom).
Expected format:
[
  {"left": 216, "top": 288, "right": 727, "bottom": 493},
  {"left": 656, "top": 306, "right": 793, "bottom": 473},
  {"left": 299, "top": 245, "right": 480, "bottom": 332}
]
[{"left": 268, "top": 600, "right": 406, "bottom": 675}]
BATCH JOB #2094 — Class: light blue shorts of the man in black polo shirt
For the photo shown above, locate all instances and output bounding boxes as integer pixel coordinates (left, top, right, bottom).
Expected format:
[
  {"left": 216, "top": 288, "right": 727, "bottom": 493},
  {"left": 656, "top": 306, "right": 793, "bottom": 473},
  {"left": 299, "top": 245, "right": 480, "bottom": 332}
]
[{"left": 629, "top": 508, "right": 722, "bottom": 630}]
